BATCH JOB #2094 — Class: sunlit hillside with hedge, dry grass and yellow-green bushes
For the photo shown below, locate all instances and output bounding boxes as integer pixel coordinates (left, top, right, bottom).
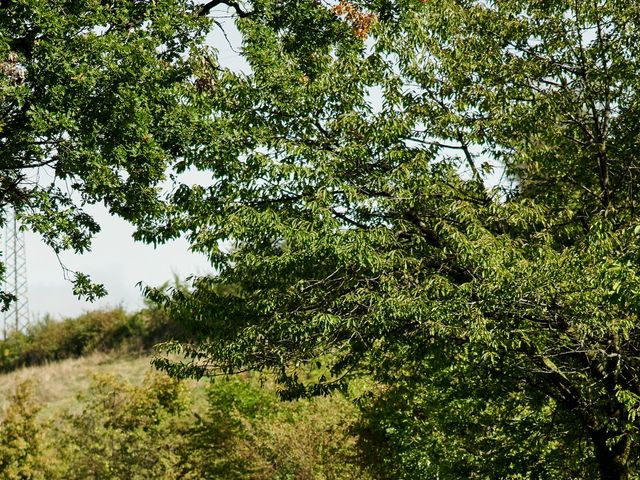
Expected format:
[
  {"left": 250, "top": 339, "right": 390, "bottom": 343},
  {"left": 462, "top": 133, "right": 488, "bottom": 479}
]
[{"left": 0, "top": 311, "right": 368, "bottom": 480}]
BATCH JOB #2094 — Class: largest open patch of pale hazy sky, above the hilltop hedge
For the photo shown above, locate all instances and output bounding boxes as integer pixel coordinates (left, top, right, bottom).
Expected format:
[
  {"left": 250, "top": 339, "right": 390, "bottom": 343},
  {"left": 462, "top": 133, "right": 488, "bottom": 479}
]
[{"left": 26, "top": 207, "right": 211, "bottom": 320}]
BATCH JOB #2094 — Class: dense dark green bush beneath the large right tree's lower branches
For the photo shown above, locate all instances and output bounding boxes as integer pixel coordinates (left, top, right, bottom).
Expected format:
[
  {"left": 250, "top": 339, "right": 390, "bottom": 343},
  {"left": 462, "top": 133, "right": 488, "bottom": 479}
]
[{"left": 357, "top": 350, "right": 598, "bottom": 480}]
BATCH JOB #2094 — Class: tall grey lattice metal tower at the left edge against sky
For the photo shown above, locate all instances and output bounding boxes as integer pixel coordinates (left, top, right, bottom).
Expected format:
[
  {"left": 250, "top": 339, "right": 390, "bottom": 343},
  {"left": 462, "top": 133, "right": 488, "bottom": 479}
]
[{"left": 2, "top": 208, "right": 29, "bottom": 338}]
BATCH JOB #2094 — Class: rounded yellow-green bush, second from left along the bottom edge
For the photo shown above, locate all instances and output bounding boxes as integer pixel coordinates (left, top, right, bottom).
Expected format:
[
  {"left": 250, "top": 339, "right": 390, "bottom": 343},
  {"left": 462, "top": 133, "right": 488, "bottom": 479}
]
[{"left": 54, "top": 376, "right": 188, "bottom": 480}]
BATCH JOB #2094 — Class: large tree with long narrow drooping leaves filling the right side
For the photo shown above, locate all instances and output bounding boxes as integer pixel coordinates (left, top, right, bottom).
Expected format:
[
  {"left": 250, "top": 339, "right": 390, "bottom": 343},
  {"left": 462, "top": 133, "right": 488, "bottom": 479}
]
[{"left": 140, "top": 0, "right": 640, "bottom": 479}]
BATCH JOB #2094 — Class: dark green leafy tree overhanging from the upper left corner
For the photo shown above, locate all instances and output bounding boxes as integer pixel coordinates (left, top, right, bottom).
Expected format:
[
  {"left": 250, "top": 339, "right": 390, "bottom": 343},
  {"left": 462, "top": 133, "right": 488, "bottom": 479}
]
[{"left": 0, "top": 0, "right": 206, "bottom": 300}]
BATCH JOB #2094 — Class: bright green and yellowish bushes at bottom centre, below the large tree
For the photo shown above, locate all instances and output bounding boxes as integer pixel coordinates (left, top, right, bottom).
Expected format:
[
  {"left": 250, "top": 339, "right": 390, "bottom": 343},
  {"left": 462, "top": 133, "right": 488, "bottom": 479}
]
[{"left": 182, "top": 379, "right": 368, "bottom": 480}]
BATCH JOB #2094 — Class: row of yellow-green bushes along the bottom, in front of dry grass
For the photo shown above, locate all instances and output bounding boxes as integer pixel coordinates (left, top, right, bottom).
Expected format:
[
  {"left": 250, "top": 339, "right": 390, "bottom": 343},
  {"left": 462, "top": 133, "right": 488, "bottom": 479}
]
[{"left": 0, "top": 350, "right": 368, "bottom": 480}]
